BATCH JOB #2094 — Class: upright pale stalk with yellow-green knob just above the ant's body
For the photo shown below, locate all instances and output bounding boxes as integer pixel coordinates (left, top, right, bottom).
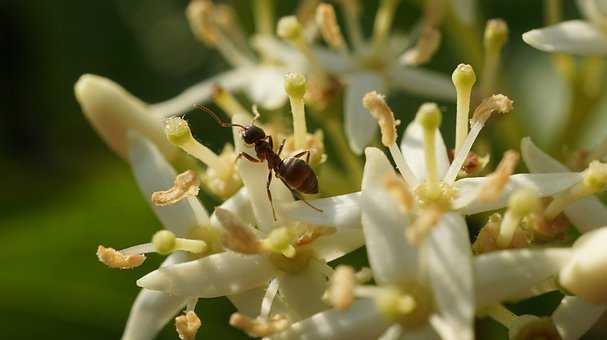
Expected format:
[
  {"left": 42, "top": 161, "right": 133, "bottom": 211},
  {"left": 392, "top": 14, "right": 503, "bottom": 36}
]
[{"left": 285, "top": 73, "right": 308, "bottom": 149}]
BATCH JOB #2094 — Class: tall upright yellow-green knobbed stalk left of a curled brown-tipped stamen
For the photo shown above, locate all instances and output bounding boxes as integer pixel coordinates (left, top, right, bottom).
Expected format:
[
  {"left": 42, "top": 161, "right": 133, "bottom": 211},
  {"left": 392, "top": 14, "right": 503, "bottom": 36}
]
[{"left": 451, "top": 64, "right": 476, "bottom": 153}]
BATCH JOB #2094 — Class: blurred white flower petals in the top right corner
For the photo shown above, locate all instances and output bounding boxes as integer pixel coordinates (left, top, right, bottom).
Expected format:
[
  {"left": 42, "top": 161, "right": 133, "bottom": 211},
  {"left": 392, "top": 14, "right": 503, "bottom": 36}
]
[{"left": 523, "top": 0, "right": 607, "bottom": 56}]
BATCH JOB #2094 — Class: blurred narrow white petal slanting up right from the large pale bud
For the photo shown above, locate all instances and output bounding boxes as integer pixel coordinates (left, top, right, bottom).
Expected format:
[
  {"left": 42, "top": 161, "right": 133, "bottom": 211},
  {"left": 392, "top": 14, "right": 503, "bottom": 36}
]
[{"left": 150, "top": 67, "right": 256, "bottom": 117}]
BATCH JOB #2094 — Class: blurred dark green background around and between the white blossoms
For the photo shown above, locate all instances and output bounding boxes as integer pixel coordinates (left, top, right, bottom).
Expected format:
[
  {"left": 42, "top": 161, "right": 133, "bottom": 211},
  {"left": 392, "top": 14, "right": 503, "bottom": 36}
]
[{"left": 0, "top": 0, "right": 605, "bottom": 339}]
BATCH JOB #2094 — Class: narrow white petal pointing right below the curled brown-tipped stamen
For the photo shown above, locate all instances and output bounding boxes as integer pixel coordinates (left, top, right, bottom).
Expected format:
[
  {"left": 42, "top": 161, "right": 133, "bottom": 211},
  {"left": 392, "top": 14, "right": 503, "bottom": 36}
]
[{"left": 453, "top": 172, "right": 582, "bottom": 215}]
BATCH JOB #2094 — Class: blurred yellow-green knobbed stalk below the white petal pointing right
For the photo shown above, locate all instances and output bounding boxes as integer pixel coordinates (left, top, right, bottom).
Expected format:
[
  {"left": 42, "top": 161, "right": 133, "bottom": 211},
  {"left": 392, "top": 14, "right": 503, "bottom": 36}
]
[{"left": 496, "top": 188, "right": 542, "bottom": 249}]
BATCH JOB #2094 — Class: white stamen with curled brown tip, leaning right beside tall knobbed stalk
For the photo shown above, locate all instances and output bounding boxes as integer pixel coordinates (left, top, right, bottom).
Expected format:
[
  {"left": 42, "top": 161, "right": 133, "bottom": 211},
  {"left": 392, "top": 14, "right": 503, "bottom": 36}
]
[{"left": 443, "top": 94, "right": 513, "bottom": 185}]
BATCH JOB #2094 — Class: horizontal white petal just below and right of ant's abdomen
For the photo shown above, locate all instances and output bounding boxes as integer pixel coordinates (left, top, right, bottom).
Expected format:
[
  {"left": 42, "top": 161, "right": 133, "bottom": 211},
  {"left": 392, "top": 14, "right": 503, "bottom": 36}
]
[{"left": 281, "top": 192, "right": 362, "bottom": 229}]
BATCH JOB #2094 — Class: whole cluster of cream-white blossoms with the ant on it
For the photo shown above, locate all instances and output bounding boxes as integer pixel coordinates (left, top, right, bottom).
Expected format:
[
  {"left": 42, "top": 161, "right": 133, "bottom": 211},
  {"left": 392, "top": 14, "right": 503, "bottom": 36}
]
[{"left": 75, "top": 0, "right": 607, "bottom": 340}]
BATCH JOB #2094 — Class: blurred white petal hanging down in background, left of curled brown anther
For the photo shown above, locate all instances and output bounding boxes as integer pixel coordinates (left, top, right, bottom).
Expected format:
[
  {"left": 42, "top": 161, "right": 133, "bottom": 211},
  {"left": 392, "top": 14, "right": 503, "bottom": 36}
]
[{"left": 344, "top": 72, "right": 385, "bottom": 154}]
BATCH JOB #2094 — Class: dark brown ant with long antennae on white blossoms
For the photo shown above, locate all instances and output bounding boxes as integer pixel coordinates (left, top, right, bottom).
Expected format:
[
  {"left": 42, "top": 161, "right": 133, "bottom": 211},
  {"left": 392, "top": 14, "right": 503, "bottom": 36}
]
[{"left": 194, "top": 104, "right": 322, "bottom": 220}]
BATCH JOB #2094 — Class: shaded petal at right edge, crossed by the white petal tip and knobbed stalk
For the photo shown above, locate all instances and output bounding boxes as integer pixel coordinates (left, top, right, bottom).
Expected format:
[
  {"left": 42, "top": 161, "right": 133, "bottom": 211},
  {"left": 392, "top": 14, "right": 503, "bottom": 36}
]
[{"left": 521, "top": 137, "right": 607, "bottom": 233}]
